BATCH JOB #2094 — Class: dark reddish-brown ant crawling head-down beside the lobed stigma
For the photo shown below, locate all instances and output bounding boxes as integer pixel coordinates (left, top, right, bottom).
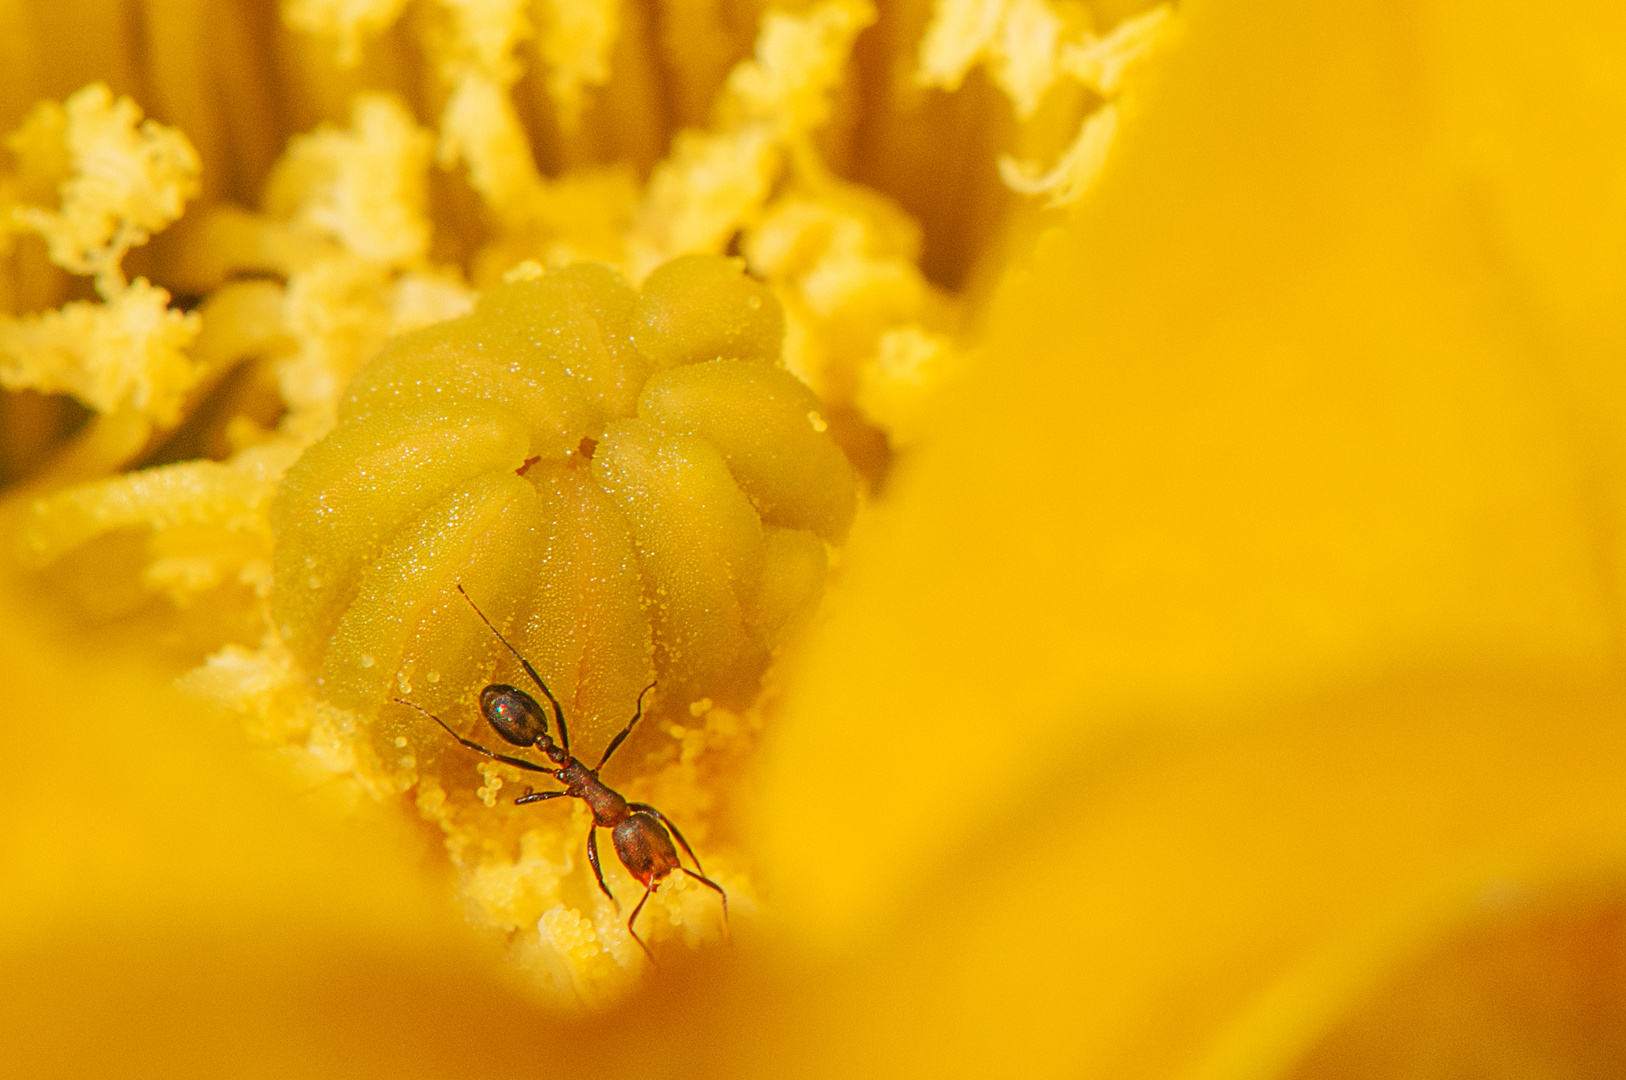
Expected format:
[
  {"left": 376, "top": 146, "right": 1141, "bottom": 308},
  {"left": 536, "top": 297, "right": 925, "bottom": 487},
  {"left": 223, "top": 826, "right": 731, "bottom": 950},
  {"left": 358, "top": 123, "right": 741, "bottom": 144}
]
[{"left": 395, "top": 584, "right": 728, "bottom": 963}]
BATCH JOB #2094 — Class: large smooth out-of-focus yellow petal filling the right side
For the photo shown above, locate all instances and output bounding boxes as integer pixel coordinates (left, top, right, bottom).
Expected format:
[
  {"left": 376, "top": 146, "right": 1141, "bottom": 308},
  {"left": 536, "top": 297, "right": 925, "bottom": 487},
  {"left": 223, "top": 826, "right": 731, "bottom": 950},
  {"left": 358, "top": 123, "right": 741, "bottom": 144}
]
[{"left": 764, "top": 2, "right": 1626, "bottom": 1077}]
